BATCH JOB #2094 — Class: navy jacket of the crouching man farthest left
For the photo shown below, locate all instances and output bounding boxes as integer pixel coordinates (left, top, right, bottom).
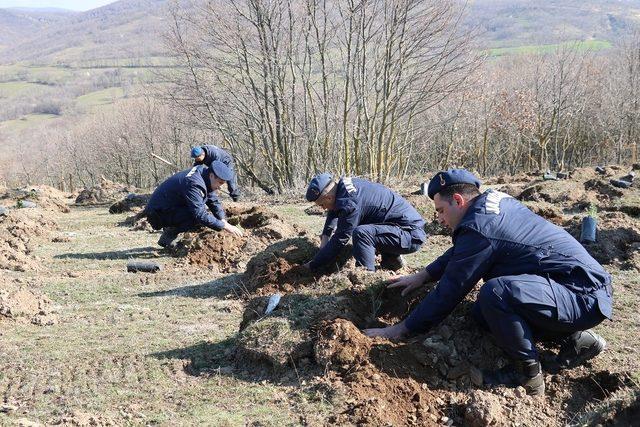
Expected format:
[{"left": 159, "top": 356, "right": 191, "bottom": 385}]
[{"left": 146, "top": 165, "right": 225, "bottom": 230}]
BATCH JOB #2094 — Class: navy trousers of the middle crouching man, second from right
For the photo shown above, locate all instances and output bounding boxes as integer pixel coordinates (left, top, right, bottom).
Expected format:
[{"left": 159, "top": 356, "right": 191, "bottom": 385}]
[{"left": 351, "top": 224, "right": 427, "bottom": 271}]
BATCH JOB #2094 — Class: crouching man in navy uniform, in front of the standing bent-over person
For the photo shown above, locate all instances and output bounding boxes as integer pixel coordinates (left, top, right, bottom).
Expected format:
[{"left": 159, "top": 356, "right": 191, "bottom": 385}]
[{"left": 145, "top": 160, "right": 242, "bottom": 247}]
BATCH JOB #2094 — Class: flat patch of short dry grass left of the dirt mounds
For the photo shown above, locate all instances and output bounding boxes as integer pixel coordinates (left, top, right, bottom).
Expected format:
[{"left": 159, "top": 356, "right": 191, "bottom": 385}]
[{"left": 0, "top": 209, "right": 338, "bottom": 425}]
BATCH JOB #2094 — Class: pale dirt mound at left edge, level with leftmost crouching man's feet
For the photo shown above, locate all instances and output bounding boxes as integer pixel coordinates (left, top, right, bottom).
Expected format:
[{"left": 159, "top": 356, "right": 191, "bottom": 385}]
[{"left": 0, "top": 209, "right": 57, "bottom": 271}]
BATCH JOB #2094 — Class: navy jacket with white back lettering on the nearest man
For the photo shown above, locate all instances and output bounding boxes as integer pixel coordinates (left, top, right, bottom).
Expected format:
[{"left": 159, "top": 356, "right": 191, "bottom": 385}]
[{"left": 405, "top": 190, "right": 613, "bottom": 332}]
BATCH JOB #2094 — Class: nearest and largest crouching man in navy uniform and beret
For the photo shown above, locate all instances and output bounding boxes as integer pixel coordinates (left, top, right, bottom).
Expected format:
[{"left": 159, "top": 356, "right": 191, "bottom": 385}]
[{"left": 364, "top": 169, "right": 613, "bottom": 394}]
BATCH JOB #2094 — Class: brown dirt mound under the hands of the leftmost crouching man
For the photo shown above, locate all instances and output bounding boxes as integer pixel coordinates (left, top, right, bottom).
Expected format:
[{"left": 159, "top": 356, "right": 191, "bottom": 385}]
[{"left": 175, "top": 206, "right": 302, "bottom": 272}]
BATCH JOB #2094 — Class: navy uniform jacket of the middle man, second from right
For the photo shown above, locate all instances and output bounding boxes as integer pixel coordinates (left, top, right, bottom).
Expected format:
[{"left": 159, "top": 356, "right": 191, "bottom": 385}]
[{"left": 310, "top": 177, "right": 424, "bottom": 269}]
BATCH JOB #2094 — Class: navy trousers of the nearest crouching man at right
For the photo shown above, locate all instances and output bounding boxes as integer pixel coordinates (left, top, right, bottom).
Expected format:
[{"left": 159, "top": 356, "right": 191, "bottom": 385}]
[{"left": 472, "top": 274, "right": 605, "bottom": 360}]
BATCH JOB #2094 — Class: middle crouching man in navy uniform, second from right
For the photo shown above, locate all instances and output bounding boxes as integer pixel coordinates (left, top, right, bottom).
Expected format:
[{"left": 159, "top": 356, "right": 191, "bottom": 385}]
[{"left": 305, "top": 173, "right": 427, "bottom": 271}]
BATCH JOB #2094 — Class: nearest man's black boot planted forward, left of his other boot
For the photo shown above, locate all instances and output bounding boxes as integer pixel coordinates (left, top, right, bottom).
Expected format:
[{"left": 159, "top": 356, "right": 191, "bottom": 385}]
[{"left": 470, "top": 360, "right": 544, "bottom": 396}]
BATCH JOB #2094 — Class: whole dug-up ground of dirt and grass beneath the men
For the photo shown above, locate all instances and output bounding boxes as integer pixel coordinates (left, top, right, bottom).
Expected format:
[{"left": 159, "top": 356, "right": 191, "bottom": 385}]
[{"left": 0, "top": 168, "right": 640, "bottom": 426}]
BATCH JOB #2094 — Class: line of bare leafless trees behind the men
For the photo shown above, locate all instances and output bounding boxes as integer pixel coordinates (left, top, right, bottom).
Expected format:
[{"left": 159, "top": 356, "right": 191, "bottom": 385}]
[{"left": 1, "top": 0, "right": 640, "bottom": 192}]
